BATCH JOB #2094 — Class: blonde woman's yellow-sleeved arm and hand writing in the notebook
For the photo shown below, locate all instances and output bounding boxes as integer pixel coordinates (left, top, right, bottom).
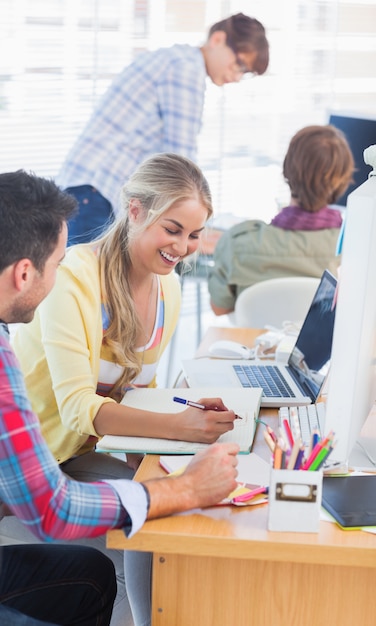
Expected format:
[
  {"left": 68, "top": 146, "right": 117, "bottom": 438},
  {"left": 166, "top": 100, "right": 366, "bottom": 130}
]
[{"left": 39, "top": 249, "right": 235, "bottom": 443}]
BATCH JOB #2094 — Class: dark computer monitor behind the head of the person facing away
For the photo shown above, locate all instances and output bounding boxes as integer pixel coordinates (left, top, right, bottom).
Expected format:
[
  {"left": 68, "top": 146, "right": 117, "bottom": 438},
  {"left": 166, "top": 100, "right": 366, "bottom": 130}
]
[{"left": 329, "top": 113, "right": 376, "bottom": 207}]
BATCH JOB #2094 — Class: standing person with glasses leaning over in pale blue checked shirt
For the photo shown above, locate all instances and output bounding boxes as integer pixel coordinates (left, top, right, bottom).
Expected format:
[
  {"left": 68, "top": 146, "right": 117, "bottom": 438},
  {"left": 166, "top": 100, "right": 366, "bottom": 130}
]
[{"left": 56, "top": 13, "right": 269, "bottom": 244}]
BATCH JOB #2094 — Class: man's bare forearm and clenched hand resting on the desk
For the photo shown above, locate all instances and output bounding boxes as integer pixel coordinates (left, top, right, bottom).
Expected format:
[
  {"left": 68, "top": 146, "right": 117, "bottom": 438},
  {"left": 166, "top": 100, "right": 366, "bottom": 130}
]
[{"left": 145, "top": 443, "right": 239, "bottom": 519}]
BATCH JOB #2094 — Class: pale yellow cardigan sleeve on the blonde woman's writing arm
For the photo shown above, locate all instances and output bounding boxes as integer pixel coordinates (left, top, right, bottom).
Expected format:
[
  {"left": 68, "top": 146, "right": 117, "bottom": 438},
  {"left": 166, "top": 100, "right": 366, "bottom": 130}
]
[{"left": 37, "top": 249, "right": 115, "bottom": 436}]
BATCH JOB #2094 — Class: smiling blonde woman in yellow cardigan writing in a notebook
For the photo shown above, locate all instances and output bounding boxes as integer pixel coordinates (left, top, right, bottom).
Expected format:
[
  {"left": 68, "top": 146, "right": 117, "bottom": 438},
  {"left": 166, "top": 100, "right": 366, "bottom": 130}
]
[{"left": 14, "top": 154, "right": 235, "bottom": 624}]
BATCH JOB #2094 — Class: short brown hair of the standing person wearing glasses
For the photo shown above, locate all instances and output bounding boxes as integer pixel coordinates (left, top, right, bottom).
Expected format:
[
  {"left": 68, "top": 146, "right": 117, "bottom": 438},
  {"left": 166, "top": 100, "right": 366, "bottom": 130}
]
[{"left": 209, "top": 13, "right": 269, "bottom": 74}]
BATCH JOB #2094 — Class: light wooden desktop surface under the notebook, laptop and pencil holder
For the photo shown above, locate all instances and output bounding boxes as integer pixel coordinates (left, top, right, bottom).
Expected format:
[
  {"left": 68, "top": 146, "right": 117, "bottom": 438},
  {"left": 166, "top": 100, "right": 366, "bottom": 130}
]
[{"left": 107, "top": 327, "right": 376, "bottom": 568}]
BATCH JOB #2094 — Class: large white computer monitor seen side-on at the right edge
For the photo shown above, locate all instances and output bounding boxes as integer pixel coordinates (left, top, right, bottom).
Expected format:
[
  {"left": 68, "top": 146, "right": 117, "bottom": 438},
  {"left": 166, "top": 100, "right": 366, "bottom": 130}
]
[{"left": 325, "top": 148, "right": 376, "bottom": 466}]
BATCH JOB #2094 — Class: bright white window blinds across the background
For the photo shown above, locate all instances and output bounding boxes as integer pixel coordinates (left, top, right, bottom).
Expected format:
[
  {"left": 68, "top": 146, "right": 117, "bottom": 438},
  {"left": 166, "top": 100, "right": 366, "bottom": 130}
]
[{"left": 0, "top": 0, "right": 376, "bottom": 219}]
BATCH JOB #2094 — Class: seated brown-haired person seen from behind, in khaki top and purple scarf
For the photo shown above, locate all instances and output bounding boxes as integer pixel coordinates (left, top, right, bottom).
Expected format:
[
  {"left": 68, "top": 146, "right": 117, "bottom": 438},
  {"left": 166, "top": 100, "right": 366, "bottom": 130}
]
[{"left": 208, "top": 125, "right": 354, "bottom": 315}]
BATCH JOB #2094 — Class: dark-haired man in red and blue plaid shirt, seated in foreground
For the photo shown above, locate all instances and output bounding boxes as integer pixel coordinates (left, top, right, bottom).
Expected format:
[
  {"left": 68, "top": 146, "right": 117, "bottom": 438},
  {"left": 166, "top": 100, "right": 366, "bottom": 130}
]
[{"left": 0, "top": 170, "right": 238, "bottom": 626}]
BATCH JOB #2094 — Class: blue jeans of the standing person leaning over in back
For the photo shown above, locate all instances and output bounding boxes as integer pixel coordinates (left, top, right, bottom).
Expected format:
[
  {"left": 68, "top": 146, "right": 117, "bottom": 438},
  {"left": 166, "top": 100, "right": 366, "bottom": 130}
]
[{"left": 65, "top": 185, "right": 114, "bottom": 246}]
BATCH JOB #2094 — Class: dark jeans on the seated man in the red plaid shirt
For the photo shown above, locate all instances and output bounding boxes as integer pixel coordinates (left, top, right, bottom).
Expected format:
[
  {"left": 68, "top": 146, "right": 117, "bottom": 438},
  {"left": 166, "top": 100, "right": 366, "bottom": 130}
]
[{"left": 0, "top": 544, "right": 116, "bottom": 626}]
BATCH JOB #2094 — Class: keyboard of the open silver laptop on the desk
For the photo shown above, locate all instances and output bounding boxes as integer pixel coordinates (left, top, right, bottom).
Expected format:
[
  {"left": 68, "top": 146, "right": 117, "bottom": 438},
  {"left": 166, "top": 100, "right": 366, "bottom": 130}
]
[{"left": 233, "top": 365, "right": 295, "bottom": 398}]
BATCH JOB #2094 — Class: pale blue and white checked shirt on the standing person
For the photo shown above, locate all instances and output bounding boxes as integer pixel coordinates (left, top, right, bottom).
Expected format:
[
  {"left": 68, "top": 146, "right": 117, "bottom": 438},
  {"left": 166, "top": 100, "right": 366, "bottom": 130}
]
[{"left": 57, "top": 45, "right": 206, "bottom": 212}]
